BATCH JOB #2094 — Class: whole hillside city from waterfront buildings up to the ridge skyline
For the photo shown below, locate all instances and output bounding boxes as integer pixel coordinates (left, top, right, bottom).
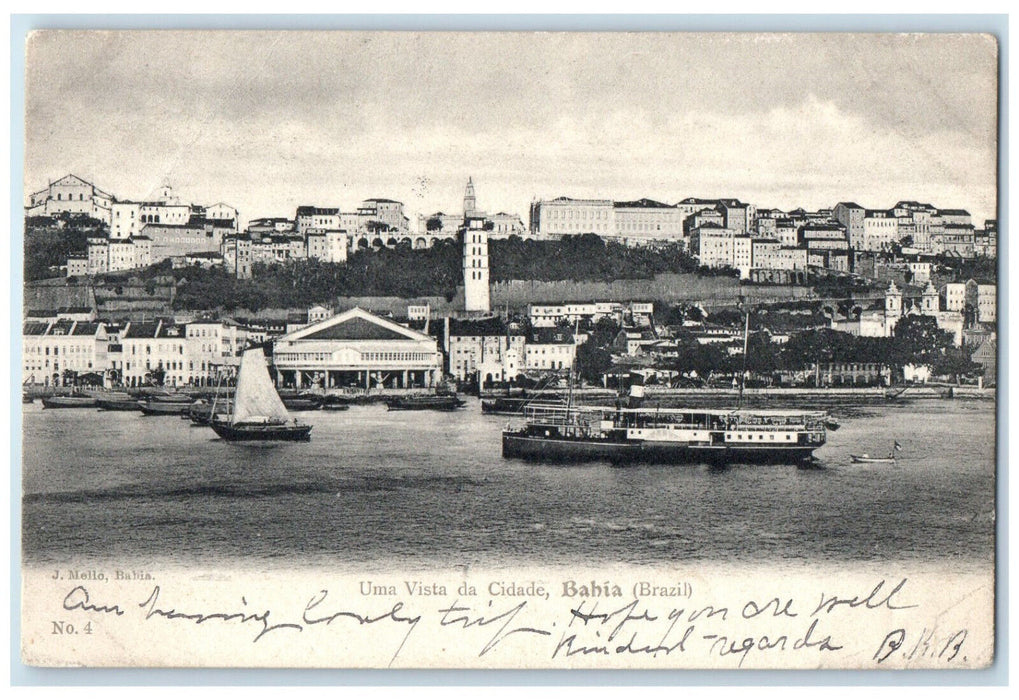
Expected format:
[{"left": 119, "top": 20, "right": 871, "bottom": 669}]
[{"left": 22, "top": 174, "right": 998, "bottom": 391}]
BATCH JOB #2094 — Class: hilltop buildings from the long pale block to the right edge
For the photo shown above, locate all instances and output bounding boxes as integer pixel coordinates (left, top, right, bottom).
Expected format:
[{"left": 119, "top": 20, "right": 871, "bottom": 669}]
[{"left": 530, "top": 197, "right": 998, "bottom": 283}]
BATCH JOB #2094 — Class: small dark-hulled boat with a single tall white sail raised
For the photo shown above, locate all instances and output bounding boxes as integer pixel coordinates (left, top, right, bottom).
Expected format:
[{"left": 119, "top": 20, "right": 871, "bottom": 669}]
[{"left": 210, "top": 347, "right": 312, "bottom": 441}]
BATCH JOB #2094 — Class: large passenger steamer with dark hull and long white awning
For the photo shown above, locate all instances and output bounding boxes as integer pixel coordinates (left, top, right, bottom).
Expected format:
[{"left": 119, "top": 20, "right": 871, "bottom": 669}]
[{"left": 502, "top": 405, "right": 826, "bottom": 465}]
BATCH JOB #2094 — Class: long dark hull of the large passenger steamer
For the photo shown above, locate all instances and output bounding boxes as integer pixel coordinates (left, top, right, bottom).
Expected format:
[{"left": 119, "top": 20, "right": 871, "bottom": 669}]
[{"left": 502, "top": 433, "right": 819, "bottom": 465}]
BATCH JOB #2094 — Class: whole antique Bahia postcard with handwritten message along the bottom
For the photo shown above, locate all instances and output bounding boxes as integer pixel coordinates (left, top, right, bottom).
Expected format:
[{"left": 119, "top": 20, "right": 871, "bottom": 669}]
[{"left": 15, "top": 30, "right": 999, "bottom": 670}]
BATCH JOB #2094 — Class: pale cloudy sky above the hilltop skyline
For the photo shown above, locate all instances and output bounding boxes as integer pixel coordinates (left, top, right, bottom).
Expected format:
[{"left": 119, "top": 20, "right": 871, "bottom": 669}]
[{"left": 24, "top": 31, "right": 998, "bottom": 225}]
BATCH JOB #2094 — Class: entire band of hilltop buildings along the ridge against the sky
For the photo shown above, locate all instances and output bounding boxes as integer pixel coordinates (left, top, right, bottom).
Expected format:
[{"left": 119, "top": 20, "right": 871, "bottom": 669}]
[{"left": 37, "top": 175, "right": 998, "bottom": 284}]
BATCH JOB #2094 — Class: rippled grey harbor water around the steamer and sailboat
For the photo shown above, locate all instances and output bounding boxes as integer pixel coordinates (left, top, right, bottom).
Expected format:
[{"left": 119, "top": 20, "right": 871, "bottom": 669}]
[{"left": 22, "top": 399, "right": 995, "bottom": 569}]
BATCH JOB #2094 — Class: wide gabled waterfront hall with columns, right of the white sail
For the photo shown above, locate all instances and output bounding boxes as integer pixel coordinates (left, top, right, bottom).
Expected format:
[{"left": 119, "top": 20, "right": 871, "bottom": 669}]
[{"left": 273, "top": 308, "right": 442, "bottom": 389}]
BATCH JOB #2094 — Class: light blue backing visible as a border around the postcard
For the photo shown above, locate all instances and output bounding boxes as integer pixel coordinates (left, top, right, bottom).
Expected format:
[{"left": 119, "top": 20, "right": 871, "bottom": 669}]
[{"left": 9, "top": 14, "right": 1009, "bottom": 686}]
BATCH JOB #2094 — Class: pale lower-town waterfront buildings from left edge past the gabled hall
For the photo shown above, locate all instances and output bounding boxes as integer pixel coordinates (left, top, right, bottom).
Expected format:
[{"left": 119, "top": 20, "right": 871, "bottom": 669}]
[{"left": 22, "top": 299, "right": 577, "bottom": 389}]
